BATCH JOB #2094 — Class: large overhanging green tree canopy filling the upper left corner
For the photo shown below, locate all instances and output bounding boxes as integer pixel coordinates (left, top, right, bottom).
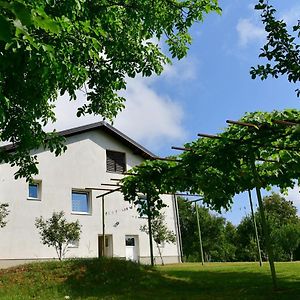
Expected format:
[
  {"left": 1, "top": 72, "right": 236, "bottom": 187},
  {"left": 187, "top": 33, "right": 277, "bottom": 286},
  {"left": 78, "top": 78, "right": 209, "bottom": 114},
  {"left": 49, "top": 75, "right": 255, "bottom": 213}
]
[{"left": 0, "top": 0, "right": 220, "bottom": 179}]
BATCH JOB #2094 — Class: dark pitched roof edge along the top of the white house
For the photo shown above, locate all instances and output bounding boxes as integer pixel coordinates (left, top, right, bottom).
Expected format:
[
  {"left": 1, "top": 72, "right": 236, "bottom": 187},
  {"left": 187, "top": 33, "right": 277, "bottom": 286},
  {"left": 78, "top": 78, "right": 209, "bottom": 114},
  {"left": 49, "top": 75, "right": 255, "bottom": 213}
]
[{"left": 1, "top": 121, "right": 157, "bottom": 159}]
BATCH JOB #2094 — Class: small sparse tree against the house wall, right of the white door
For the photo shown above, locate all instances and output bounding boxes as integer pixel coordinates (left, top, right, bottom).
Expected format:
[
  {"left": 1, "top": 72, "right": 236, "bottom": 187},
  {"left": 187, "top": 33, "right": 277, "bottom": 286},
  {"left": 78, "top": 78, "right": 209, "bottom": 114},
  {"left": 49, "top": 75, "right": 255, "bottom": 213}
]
[{"left": 140, "top": 213, "right": 176, "bottom": 265}]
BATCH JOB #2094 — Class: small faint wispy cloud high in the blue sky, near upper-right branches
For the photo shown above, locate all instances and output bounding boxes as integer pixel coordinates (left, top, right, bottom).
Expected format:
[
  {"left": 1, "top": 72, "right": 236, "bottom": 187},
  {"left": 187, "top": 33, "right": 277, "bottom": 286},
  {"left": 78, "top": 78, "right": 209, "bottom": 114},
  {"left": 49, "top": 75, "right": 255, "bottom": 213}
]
[{"left": 236, "top": 19, "right": 266, "bottom": 47}]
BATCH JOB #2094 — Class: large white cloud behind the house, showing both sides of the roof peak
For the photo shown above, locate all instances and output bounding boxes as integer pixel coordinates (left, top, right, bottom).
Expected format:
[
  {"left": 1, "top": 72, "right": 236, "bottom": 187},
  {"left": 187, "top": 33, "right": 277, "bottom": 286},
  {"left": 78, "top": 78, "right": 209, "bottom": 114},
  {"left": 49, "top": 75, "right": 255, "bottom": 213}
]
[{"left": 47, "top": 73, "right": 186, "bottom": 151}]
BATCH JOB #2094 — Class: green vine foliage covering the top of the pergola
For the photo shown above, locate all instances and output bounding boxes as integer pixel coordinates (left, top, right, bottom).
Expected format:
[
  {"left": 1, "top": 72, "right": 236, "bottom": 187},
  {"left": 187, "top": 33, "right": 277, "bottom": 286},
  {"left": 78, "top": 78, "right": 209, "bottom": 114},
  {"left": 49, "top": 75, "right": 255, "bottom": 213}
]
[{"left": 122, "top": 109, "right": 300, "bottom": 211}]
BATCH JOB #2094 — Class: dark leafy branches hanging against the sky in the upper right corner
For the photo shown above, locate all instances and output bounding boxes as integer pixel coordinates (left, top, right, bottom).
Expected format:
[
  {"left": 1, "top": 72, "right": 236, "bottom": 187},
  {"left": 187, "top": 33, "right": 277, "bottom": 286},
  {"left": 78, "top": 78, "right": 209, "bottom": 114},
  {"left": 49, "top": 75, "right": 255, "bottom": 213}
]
[{"left": 250, "top": 0, "right": 300, "bottom": 97}]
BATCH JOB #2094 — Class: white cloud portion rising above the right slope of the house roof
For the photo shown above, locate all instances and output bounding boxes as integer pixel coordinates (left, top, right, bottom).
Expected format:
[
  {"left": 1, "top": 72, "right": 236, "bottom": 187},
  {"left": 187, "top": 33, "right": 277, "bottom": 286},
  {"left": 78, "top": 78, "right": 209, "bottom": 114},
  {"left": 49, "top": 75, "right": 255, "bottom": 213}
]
[{"left": 115, "top": 78, "right": 186, "bottom": 150}]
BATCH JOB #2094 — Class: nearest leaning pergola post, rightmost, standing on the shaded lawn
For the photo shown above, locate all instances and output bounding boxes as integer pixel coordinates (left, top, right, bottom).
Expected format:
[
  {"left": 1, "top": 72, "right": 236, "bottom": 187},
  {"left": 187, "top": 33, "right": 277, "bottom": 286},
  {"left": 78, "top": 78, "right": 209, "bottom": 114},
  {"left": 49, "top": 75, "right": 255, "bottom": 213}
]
[{"left": 251, "top": 159, "right": 277, "bottom": 289}]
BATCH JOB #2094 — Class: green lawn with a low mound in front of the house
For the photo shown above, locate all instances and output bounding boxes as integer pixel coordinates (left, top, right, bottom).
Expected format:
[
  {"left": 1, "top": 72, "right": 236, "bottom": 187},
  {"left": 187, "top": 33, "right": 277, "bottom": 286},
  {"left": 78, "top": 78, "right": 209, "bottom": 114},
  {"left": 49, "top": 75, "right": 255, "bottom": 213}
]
[{"left": 0, "top": 259, "right": 300, "bottom": 300}]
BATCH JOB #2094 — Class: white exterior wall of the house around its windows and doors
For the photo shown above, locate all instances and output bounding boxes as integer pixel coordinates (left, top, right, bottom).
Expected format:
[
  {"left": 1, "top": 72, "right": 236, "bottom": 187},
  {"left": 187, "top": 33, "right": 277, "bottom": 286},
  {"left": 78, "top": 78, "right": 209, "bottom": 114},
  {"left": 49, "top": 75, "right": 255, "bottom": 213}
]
[{"left": 0, "top": 130, "right": 179, "bottom": 263}]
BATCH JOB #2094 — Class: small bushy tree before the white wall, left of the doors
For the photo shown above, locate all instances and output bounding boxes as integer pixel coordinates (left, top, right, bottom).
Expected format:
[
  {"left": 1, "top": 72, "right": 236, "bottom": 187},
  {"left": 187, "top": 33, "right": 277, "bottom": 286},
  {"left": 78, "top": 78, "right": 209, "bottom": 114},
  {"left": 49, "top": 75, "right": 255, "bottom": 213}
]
[{"left": 35, "top": 211, "right": 81, "bottom": 260}]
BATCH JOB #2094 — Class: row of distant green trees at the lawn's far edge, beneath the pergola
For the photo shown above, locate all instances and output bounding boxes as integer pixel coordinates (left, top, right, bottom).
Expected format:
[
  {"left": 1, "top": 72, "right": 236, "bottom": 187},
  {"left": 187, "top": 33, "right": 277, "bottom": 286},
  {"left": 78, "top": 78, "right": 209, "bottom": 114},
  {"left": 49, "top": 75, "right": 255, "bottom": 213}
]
[{"left": 178, "top": 193, "right": 300, "bottom": 261}]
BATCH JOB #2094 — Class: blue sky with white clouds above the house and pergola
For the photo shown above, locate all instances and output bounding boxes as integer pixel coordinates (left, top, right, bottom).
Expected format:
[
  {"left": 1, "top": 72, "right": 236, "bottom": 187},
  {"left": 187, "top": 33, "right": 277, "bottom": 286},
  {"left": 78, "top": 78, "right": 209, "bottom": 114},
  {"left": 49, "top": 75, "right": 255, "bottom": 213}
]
[{"left": 57, "top": 0, "right": 300, "bottom": 224}]
